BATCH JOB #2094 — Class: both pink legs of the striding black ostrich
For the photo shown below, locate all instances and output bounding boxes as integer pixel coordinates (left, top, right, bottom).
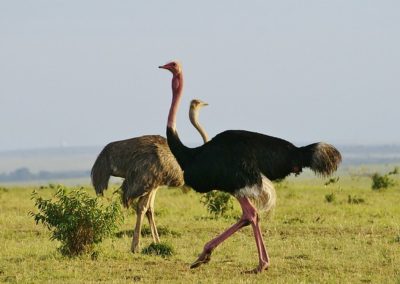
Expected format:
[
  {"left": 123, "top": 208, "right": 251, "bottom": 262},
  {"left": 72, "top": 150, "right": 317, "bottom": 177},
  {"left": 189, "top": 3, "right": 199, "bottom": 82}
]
[{"left": 190, "top": 197, "right": 269, "bottom": 273}]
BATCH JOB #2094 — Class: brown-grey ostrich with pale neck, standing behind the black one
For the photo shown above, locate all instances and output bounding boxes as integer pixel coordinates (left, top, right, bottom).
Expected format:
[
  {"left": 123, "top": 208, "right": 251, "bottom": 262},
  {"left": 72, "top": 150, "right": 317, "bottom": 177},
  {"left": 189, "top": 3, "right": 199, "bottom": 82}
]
[{"left": 91, "top": 99, "right": 208, "bottom": 252}]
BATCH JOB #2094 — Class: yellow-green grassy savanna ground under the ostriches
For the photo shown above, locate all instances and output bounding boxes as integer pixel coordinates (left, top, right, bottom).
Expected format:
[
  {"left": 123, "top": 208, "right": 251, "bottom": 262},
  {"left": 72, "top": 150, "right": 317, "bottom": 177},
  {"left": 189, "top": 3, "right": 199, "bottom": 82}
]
[{"left": 0, "top": 165, "right": 400, "bottom": 283}]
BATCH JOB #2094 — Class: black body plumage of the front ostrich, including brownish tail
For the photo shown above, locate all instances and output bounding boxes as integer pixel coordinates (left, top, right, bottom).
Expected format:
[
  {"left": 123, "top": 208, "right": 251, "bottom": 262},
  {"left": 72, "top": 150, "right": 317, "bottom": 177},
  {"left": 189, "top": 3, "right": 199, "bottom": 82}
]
[{"left": 167, "top": 128, "right": 341, "bottom": 194}]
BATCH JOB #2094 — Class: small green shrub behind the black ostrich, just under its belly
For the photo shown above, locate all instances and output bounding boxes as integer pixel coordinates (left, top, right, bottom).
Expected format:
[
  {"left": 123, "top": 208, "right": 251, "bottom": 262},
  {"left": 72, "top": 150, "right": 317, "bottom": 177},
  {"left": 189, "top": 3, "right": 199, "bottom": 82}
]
[{"left": 201, "top": 190, "right": 233, "bottom": 218}]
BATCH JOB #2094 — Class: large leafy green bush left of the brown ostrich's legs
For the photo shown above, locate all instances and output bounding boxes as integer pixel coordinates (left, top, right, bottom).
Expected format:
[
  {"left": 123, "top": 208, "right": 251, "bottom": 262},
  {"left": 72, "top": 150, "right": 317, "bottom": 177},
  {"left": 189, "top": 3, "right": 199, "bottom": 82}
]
[{"left": 30, "top": 185, "right": 123, "bottom": 256}]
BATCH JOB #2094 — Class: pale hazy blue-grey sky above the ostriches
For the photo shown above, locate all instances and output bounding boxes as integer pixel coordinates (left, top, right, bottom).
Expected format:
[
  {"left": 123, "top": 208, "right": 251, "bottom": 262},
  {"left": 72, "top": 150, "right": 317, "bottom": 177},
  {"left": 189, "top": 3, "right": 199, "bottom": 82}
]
[{"left": 0, "top": 0, "right": 400, "bottom": 151}]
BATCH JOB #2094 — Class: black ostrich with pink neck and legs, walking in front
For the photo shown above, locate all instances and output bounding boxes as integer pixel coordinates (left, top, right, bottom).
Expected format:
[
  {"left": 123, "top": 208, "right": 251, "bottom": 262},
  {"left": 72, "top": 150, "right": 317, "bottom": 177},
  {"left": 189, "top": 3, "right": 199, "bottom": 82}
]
[{"left": 159, "top": 61, "right": 341, "bottom": 273}]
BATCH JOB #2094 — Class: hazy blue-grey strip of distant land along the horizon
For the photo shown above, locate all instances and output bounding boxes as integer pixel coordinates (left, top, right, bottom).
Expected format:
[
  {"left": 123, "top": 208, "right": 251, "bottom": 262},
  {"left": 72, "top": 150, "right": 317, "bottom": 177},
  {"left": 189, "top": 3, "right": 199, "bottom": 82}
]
[{"left": 0, "top": 144, "right": 400, "bottom": 174}]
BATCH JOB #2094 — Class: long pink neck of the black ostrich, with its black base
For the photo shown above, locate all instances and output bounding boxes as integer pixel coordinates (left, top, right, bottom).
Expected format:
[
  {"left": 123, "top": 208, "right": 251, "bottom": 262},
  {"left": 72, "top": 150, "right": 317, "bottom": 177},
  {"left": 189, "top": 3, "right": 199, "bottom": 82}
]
[{"left": 167, "top": 73, "right": 190, "bottom": 170}]
